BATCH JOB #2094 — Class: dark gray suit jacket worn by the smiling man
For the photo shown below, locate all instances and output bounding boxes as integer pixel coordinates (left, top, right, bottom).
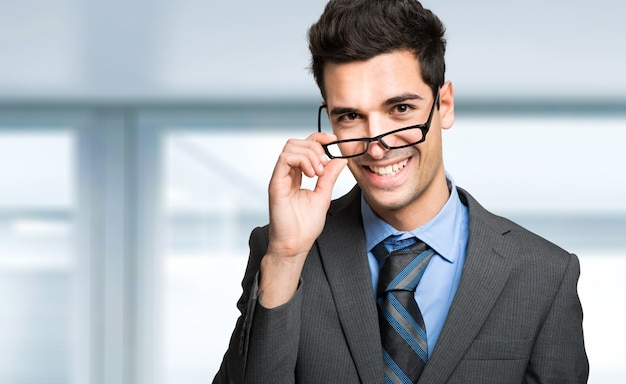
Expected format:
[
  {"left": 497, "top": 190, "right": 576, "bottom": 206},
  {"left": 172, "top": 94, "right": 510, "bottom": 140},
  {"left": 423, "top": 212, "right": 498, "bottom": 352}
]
[{"left": 213, "top": 187, "right": 589, "bottom": 384}]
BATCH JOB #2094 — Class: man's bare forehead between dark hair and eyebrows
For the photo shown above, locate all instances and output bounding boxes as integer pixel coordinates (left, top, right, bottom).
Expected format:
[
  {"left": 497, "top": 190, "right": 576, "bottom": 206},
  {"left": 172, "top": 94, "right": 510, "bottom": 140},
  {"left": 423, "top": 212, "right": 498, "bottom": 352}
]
[{"left": 324, "top": 51, "right": 429, "bottom": 108}]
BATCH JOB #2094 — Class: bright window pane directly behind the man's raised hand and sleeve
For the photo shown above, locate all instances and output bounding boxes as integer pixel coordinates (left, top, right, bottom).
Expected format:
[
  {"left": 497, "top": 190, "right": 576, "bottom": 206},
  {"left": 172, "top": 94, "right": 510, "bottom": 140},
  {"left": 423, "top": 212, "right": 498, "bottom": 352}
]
[{"left": 140, "top": 108, "right": 353, "bottom": 384}]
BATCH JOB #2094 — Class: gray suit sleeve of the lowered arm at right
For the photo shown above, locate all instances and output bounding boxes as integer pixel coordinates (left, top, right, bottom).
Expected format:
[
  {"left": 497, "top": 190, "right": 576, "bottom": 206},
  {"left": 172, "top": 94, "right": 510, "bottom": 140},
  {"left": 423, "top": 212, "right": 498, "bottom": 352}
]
[{"left": 525, "top": 255, "right": 589, "bottom": 383}]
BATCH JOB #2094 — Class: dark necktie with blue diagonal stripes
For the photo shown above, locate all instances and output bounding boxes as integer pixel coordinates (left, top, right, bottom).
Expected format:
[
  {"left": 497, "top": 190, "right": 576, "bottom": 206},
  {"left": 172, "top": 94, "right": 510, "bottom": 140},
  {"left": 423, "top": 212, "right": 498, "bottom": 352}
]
[{"left": 372, "top": 240, "right": 434, "bottom": 383}]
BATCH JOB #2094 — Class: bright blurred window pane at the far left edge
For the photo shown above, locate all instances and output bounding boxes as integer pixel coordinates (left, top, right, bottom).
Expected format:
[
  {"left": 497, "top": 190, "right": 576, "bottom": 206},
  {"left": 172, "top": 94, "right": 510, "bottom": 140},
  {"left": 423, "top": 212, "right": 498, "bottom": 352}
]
[{"left": 0, "top": 126, "right": 78, "bottom": 383}]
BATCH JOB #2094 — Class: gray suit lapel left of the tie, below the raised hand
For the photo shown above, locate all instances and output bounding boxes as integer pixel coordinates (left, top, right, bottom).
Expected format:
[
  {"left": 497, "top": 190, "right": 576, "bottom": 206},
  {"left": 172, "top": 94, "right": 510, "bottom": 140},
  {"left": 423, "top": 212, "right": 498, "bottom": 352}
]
[{"left": 317, "top": 188, "right": 383, "bottom": 383}]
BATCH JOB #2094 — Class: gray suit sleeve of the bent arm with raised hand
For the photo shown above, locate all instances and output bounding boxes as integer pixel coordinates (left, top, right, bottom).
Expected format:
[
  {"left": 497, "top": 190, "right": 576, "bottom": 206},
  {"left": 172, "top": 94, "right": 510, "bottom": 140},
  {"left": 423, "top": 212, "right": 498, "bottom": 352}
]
[{"left": 213, "top": 227, "right": 302, "bottom": 384}]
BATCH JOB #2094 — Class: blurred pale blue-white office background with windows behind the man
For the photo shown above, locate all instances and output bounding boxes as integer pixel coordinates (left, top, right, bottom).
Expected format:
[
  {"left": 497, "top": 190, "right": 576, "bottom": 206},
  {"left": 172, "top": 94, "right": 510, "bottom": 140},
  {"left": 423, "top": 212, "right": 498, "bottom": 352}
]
[{"left": 0, "top": 0, "right": 626, "bottom": 384}]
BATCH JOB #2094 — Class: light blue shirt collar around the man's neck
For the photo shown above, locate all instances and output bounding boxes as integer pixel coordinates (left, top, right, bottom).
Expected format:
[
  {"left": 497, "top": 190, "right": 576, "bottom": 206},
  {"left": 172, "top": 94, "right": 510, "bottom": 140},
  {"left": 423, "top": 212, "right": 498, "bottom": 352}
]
[{"left": 361, "top": 172, "right": 463, "bottom": 263}]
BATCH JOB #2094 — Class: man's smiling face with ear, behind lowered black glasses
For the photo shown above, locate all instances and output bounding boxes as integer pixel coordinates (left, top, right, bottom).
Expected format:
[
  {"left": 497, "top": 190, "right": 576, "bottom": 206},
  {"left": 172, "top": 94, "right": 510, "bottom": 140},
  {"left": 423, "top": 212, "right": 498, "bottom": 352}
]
[{"left": 324, "top": 51, "right": 454, "bottom": 230}]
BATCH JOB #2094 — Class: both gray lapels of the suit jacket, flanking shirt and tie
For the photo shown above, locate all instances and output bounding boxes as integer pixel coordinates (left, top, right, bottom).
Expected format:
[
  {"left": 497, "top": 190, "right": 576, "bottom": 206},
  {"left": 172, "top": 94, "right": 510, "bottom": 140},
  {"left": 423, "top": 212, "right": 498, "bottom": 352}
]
[{"left": 317, "top": 186, "right": 515, "bottom": 383}]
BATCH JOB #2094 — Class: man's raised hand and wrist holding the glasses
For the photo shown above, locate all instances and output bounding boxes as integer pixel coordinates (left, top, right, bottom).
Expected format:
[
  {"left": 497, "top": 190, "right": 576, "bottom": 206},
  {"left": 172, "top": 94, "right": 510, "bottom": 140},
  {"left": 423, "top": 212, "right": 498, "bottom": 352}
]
[{"left": 259, "top": 133, "right": 347, "bottom": 308}]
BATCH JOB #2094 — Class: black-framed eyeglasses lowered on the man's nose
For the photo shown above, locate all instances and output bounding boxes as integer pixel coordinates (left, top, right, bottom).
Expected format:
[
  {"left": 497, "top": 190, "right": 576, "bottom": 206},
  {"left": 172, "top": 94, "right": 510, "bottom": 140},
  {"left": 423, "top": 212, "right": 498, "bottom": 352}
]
[{"left": 317, "top": 93, "right": 439, "bottom": 159}]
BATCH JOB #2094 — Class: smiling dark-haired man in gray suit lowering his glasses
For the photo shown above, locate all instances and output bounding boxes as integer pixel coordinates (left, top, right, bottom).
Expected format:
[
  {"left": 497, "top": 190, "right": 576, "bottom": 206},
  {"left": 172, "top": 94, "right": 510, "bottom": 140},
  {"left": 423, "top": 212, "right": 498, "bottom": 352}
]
[{"left": 214, "top": 0, "right": 588, "bottom": 384}]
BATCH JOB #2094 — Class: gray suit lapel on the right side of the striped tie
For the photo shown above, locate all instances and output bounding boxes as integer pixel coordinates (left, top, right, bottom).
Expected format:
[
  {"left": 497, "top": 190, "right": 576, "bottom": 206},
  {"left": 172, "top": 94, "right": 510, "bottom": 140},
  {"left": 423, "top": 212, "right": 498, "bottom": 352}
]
[{"left": 419, "top": 191, "right": 515, "bottom": 383}]
